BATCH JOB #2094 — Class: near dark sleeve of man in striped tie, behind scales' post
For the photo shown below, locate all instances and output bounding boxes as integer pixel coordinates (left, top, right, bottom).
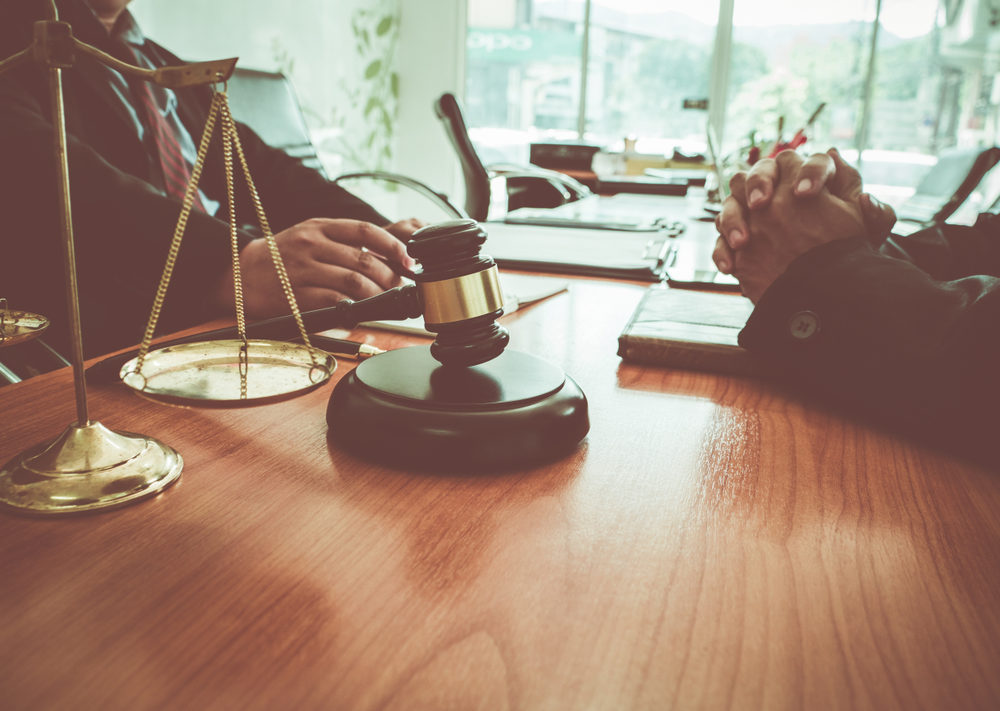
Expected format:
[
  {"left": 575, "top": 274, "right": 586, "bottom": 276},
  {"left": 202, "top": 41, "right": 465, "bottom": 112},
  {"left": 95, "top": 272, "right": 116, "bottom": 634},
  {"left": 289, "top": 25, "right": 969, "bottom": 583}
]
[{"left": 0, "top": 70, "right": 249, "bottom": 355}]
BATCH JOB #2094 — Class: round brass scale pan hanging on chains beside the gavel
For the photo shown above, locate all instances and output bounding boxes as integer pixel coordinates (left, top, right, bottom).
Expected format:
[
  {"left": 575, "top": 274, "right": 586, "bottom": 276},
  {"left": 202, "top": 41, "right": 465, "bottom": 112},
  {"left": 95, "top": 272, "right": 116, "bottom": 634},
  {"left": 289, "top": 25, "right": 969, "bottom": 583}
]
[{"left": 120, "top": 339, "right": 337, "bottom": 407}]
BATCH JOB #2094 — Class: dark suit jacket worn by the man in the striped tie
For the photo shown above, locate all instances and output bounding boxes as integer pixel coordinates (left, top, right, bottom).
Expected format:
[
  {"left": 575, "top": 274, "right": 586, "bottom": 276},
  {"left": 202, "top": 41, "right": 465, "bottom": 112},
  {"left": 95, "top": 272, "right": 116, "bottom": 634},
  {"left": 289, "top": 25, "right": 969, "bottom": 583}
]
[{"left": 0, "top": 10, "right": 388, "bottom": 355}]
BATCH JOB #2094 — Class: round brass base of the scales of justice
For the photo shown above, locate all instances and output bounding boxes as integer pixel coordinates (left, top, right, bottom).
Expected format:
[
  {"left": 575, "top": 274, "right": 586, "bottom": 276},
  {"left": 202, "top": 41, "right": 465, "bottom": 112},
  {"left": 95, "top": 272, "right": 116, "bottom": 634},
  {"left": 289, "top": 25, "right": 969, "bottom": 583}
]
[{"left": 0, "top": 422, "right": 184, "bottom": 515}]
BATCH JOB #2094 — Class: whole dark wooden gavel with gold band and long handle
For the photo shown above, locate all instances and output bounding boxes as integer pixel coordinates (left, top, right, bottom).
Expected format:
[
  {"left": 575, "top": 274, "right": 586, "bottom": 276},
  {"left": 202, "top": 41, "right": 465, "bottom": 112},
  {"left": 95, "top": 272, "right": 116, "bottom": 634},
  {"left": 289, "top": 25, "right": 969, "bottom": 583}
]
[{"left": 87, "top": 220, "right": 510, "bottom": 382}]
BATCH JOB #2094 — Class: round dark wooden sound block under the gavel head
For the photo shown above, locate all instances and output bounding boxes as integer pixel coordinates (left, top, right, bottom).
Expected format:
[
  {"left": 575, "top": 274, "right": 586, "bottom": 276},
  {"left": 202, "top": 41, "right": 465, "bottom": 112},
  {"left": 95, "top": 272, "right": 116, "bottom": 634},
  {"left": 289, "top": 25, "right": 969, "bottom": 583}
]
[{"left": 326, "top": 346, "right": 590, "bottom": 471}]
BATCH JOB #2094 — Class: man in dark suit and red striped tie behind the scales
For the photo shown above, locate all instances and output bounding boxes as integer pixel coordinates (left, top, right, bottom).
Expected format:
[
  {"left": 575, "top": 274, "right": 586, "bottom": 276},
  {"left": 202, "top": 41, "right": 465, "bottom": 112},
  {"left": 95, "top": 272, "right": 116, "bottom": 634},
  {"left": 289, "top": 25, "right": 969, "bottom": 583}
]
[{"left": 0, "top": 0, "right": 421, "bottom": 356}]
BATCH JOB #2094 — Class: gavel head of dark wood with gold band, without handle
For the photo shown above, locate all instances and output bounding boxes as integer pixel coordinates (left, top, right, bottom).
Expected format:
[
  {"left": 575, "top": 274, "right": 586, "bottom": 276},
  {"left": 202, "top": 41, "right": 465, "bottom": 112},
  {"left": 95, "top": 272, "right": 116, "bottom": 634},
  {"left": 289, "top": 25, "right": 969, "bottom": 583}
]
[{"left": 406, "top": 220, "right": 510, "bottom": 366}]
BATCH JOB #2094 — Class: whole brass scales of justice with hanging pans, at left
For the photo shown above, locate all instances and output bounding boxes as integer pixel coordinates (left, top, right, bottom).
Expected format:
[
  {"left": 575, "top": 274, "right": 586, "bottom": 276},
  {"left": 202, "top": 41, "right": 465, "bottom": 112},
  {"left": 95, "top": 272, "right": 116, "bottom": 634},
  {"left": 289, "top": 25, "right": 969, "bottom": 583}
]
[{"left": 0, "top": 0, "right": 336, "bottom": 515}]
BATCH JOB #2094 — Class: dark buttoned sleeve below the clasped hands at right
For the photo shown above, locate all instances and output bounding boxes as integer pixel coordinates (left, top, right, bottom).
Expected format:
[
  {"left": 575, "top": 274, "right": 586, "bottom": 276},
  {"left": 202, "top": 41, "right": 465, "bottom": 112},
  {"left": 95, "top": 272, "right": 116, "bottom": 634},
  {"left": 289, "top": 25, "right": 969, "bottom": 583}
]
[{"left": 740, "top": 225, "right": 1000, "bottom": 458}]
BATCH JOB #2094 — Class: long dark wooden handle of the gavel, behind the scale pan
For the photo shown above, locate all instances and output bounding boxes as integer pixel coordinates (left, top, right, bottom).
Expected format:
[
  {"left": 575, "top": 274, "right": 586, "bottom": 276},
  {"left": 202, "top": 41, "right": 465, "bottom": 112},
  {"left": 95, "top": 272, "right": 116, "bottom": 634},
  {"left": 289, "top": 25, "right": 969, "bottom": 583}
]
[{"left": 87, "top": 284, "right": 423, "bottom": 383}]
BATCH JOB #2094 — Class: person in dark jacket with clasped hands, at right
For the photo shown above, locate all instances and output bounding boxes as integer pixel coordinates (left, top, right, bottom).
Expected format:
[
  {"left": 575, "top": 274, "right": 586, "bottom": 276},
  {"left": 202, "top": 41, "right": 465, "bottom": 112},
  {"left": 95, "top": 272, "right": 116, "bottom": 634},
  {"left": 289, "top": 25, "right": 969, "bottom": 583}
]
[{"left": 714, "top": 150, "right": 1000, "bottom": 465}]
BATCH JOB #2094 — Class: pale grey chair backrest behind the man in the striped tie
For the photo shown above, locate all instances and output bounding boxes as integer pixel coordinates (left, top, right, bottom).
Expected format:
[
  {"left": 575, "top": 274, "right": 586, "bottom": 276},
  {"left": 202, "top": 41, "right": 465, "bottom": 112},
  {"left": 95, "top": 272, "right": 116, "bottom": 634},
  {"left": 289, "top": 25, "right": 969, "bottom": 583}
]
[{"left": 228, "top": 67, "right": 326, "bottom": 176}]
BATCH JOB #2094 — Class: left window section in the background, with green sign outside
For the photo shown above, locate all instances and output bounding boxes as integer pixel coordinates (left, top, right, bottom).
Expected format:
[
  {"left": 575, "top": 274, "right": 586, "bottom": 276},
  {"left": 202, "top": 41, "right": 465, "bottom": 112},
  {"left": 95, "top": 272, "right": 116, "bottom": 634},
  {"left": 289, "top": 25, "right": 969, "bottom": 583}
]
[{"left": 465, "top": 0, "right": 716, "bottom": 163}]
